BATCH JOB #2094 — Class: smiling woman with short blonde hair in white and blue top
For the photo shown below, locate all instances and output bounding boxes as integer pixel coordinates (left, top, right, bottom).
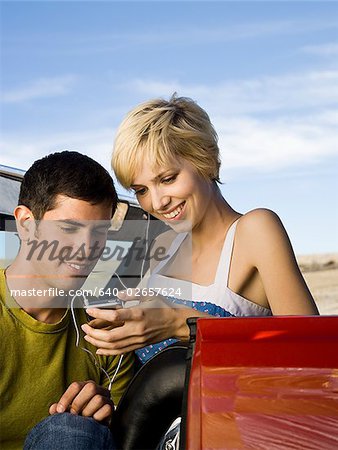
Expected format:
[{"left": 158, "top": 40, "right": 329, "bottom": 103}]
[{"left": 83, "top": 96, "right": 318, "bottom": 362}]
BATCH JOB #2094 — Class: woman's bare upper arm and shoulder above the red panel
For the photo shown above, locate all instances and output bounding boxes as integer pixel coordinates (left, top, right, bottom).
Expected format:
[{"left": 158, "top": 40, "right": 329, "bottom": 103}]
[{"left": 238, "top": 209, "right": 318, "bottom": 315}]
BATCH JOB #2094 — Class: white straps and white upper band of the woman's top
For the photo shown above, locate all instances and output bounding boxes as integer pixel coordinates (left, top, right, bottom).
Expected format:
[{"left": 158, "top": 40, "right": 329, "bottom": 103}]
[{"left": 148, "top": 219, "right": 271, "bottom": 316}]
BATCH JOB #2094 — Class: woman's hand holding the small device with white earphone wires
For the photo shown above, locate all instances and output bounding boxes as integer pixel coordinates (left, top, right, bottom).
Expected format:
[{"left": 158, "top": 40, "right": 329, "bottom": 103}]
[{"left": 81, "top": 294, "right": 195, "bottom": 355}]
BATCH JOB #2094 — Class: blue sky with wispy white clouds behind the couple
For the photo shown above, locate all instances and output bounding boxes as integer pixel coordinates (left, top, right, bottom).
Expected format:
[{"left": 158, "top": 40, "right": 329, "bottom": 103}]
[{"left": 0, "top": 1, "right": 338, "bottom": 254}]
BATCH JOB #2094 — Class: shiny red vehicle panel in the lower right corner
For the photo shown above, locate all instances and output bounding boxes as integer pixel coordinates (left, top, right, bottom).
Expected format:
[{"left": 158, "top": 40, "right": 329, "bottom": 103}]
[{"left": 185, "top": 317, "right": 338, "bottom": 450}]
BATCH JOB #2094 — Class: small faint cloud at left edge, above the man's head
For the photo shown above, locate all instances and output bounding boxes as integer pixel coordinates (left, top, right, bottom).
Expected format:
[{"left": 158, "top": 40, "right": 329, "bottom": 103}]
[{"left": 2, "top": 75, "right": 76, "bottom": 103}]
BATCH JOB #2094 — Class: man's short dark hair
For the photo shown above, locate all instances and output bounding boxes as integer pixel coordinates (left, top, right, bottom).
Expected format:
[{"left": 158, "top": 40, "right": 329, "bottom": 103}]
[{"left": 19, "top": 151, "right": 118, "bottom": 220}]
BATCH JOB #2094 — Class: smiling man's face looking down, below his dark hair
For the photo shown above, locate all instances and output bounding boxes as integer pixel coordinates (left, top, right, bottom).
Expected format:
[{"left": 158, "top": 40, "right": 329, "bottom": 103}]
[{"left": 27, "top": 195, "right": 111, "bottom": 291}]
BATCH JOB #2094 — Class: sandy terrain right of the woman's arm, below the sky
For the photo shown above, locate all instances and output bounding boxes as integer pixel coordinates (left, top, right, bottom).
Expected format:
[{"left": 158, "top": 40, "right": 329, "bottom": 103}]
[{"left": 297, "top": 253, "right": 338, "bottom": 315}]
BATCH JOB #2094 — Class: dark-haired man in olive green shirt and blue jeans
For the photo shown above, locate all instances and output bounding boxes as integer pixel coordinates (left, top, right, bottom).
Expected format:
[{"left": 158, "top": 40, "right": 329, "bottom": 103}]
[{"left": 0, "top": 151, "right": 133, "bottom": 450}]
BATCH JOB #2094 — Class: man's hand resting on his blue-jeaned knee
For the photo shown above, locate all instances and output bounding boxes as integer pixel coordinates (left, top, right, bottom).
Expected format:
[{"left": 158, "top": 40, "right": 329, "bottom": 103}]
[{"left": 49, "top": 380, "right": 114, "bottom": 422}]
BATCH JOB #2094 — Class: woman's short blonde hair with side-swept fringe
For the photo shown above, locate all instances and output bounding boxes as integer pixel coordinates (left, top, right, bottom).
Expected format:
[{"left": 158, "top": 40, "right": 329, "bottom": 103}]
[{"left": 112, "top": 94, "right": 220, "bottom": 189}]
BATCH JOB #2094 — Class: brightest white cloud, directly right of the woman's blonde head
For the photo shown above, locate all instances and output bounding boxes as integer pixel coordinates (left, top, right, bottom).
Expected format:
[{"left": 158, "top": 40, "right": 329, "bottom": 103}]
[{"left": 214, "top": 110, "right": 338, "bottom": 179}]
